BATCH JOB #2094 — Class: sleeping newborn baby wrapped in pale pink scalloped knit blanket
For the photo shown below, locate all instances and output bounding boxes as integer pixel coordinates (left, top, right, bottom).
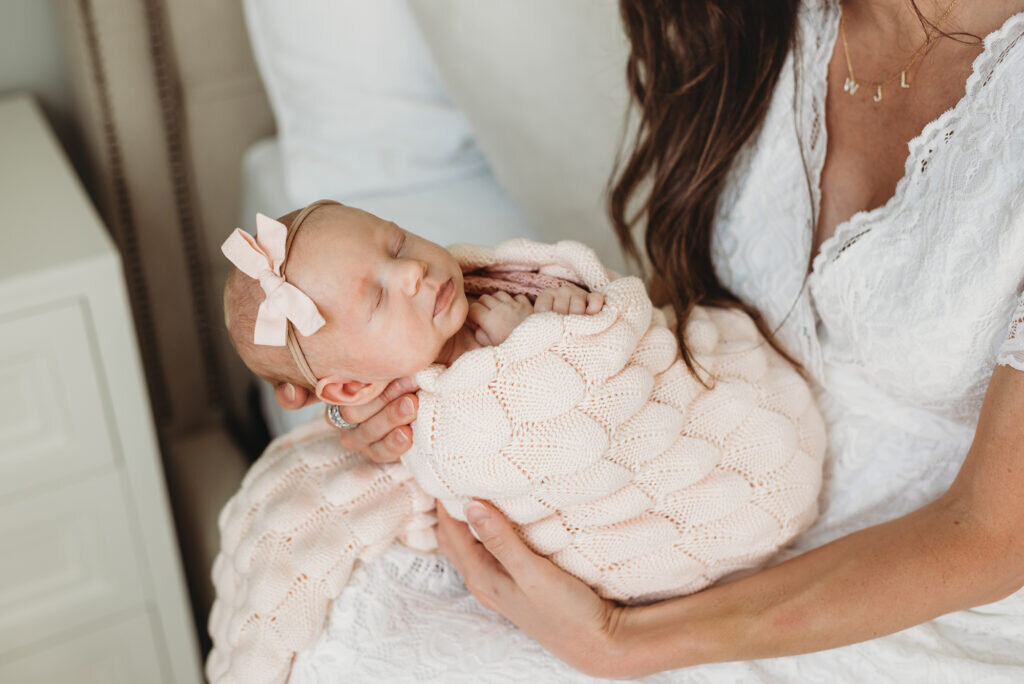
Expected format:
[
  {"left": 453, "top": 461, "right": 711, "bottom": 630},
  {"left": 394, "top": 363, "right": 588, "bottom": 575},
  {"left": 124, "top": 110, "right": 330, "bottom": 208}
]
[{"left": 207, "top": 197, "right": 824, "bottom": 684}]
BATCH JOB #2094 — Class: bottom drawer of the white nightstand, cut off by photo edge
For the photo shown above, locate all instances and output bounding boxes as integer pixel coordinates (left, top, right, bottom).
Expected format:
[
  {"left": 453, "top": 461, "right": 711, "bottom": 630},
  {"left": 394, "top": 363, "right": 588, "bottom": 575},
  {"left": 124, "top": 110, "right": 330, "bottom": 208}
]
[{"left": 0, "top": 612, "right": 163, "bottom": 684}]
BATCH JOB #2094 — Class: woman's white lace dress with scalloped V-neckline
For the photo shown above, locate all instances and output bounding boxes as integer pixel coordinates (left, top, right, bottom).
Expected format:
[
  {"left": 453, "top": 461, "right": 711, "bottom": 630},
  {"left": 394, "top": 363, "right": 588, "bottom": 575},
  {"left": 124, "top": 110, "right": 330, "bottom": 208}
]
[{"left": 291, "top": 2, "right": 1024, "bottom": 684}]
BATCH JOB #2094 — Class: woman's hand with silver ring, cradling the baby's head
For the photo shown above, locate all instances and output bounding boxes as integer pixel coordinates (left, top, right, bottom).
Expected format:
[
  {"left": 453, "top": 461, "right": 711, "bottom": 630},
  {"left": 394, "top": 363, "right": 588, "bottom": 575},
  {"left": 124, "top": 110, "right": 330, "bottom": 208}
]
[{"left": 273, "top": 378, "right": 420, "bottom": 463}]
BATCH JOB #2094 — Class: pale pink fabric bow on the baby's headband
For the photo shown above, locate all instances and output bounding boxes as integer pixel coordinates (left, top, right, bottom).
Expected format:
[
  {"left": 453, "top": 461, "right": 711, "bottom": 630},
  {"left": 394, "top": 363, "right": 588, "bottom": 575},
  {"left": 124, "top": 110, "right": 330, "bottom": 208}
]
[{"left": 220, "top": 214, "right": 326, "bottom": 347}]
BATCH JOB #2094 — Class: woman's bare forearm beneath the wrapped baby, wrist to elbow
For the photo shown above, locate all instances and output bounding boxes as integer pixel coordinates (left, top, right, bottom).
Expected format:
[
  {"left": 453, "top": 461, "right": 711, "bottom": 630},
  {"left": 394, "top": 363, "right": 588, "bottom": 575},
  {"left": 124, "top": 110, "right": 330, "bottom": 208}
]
[{"left": 618, "top": 489, "right": 1022, "bottom": 674}]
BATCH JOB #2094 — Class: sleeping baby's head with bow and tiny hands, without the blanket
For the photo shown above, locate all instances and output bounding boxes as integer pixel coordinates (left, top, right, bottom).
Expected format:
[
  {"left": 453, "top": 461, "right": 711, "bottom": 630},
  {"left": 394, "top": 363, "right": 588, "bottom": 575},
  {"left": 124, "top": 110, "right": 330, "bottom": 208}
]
[{"left": 224, "top": 197, "right": 604, "bottom": 405}]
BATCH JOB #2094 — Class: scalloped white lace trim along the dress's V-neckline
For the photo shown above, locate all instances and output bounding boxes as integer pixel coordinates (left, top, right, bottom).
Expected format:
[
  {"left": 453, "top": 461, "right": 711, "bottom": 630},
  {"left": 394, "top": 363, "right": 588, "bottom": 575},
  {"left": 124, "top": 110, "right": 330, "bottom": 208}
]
[{"left": 811, "top": 8, "right": 1024, "bottom": 279}]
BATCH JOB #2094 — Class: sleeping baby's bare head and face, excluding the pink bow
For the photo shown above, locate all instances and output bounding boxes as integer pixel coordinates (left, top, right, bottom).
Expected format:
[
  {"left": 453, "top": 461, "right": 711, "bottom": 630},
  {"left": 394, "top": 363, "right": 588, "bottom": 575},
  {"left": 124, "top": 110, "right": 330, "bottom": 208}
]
[{"left": 224, "top": 203, "right": 469, "bottom": 405}]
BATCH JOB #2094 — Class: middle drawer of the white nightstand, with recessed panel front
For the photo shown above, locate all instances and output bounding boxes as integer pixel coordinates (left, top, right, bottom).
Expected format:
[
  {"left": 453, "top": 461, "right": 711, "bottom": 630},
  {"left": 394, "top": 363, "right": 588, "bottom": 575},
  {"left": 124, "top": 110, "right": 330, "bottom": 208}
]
[{"left": 0, "top": 469, "right": 143, "bottom": 657}]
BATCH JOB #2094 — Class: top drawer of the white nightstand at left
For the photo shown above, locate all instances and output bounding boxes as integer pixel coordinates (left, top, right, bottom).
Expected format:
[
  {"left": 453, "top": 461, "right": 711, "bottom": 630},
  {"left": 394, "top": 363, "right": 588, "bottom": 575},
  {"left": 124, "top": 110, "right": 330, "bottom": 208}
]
[{"left": 0, "top": 302, "right": 114, "bottom": 501}]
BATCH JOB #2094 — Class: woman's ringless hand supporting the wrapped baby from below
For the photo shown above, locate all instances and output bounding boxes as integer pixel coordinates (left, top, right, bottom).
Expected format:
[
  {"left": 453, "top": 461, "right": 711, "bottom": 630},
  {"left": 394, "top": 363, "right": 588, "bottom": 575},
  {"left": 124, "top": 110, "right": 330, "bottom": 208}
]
[{"left": 437, "top": 502, "right": 631, "bottom": 677}]
